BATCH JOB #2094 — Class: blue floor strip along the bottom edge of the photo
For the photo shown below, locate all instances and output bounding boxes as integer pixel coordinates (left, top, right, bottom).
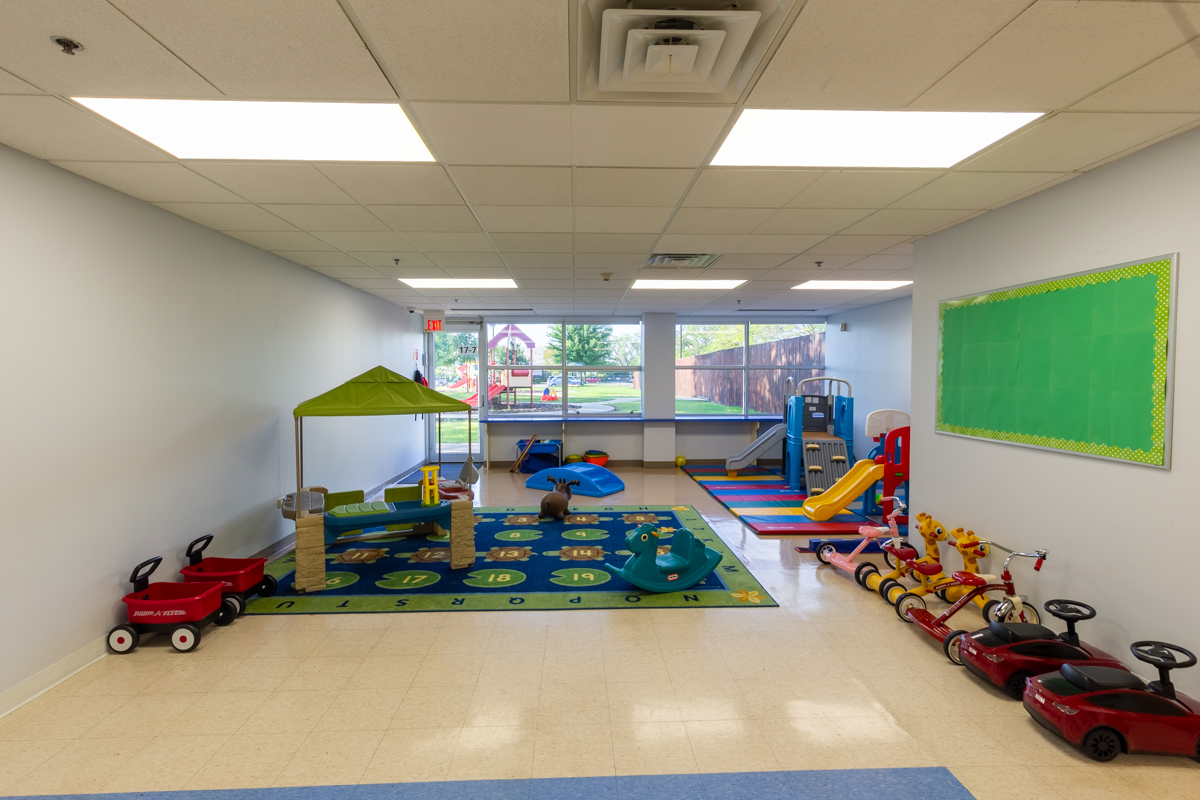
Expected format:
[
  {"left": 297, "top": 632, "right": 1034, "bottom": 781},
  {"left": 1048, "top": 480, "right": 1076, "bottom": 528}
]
[{"left": 18, "top": 766, "right": 973, "bottom": 800}]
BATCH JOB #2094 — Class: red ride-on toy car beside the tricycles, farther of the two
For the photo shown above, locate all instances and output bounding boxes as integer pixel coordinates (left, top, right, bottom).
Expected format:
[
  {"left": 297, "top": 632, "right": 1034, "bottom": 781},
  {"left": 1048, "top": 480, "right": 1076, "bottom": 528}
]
[{"left": 959, "top": 600, "right": 1124, "bottom": 700}]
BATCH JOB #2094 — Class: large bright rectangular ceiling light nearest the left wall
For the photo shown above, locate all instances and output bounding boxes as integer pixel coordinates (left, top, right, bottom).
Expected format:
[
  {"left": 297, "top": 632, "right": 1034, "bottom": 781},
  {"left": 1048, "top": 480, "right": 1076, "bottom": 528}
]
[{"left": 72, "top": 97, "right": 433, "bottom": 161}]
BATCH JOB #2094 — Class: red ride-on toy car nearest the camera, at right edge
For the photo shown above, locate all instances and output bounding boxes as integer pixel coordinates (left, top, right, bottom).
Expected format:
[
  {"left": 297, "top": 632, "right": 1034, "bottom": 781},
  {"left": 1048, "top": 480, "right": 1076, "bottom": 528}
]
[{"left": 1025, "top": 642, "right": 1200, "bottom": 762}]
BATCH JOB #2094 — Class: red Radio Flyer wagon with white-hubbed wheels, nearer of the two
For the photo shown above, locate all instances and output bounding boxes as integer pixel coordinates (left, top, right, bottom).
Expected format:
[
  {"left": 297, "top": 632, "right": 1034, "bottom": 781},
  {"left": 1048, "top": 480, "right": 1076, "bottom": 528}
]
[{"left": 108, "top": 555, "right": 238, "bottom": 655}]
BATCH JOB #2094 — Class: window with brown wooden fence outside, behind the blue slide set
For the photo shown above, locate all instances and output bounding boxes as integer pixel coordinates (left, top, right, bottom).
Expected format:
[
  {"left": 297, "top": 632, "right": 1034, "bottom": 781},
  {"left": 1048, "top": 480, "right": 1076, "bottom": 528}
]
[{"left": 676, "top": 323, "right": 824, "bottom": 416}]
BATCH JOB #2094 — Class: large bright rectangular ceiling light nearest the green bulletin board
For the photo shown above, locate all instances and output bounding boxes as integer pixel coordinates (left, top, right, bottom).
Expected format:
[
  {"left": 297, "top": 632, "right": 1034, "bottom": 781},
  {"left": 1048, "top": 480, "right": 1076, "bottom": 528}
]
[{"left": 713, "top": 108, "right": 1042, "bottom": 169}]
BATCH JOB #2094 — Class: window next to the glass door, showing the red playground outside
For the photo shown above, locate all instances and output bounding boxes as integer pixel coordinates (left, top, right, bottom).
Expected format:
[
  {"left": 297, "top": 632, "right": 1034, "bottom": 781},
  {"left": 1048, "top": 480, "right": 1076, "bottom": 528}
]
[{"left": 485, "top": 323, "right": 642, "bottom": 417}]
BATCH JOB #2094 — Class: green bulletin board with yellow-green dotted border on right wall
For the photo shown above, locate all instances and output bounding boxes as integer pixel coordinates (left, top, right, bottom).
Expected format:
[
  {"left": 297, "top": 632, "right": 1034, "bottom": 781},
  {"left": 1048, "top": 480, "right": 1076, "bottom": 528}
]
[{"left": 936, "top": 255, "right": 1175, "bottom": 468}]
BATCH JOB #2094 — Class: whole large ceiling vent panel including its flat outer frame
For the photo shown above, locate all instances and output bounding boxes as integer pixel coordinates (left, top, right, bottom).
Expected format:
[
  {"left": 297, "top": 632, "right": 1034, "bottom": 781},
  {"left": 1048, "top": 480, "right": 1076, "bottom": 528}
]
[{"left": 576, "top": 0, "right": 798, "bottom": 103}]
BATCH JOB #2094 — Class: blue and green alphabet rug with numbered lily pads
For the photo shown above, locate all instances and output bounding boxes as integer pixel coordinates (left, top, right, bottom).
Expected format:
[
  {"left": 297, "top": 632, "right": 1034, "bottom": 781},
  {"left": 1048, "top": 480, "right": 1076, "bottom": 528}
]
[{"left": 246, "top": 506, "right": 778, "bottom": 614}]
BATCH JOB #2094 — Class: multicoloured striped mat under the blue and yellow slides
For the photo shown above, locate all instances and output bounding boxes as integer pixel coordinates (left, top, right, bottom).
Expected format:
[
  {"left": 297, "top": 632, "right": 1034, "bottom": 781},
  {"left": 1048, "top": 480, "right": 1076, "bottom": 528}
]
[{"left": 683, "top": 464, "right": 874, "bottom": 536}]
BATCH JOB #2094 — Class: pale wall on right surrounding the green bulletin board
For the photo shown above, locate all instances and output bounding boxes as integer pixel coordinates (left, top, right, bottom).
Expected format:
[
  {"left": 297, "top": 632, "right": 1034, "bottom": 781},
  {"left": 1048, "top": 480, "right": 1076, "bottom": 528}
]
[{"left": 912, "top": 132, "right": 1200, "bottom": 697}]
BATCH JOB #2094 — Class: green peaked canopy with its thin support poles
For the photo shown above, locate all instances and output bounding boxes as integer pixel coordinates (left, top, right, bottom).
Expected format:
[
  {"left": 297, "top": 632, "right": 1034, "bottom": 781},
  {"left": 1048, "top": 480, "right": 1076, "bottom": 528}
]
[{"left": 292, "top": 367, "right": 470, "bottom": 498}]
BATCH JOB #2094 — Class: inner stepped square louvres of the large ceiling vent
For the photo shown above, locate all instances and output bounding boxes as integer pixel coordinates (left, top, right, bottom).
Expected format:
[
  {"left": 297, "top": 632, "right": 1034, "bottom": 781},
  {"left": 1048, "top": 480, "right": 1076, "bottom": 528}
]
[{"left": 600, "top": 8, "right": 762, "bottom": 95}]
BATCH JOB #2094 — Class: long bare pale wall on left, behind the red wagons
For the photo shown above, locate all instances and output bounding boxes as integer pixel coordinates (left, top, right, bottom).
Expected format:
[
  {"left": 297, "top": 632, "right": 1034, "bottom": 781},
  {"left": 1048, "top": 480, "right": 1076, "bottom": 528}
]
[{"left": 0, "top": 146, "right": 424, "bottom": 714}]
